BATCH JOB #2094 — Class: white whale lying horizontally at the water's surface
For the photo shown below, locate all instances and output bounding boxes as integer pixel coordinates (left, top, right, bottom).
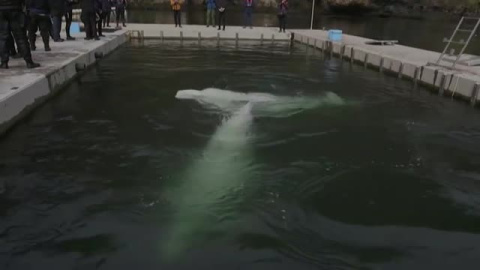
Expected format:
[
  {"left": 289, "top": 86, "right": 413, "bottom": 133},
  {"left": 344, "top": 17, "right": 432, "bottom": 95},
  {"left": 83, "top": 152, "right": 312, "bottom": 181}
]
[{"left": 175, "top": 88, "right": 345, "bottom": 117}]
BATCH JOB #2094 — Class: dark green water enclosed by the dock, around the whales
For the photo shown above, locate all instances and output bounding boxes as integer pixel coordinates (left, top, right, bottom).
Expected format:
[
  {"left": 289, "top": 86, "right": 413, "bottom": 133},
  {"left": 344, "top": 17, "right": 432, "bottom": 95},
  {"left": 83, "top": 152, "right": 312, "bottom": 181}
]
[{"left": 0, "top": 43, "right": 480, "bottom": 269}]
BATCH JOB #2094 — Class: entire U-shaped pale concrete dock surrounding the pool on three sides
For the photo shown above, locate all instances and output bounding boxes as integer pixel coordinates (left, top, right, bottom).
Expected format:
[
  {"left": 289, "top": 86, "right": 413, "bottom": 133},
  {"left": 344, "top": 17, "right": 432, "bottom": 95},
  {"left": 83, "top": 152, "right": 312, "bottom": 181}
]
[{"left": 0, "top": 24, "right": 480, "bottom": 135}]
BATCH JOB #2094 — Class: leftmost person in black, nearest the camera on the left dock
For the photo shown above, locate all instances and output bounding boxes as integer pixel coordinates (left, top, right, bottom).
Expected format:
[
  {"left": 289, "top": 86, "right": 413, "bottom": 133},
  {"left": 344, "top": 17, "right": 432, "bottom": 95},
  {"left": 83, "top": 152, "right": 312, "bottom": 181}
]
[{"left": 0, "top": 0, "right": 40, "bottom": 69}]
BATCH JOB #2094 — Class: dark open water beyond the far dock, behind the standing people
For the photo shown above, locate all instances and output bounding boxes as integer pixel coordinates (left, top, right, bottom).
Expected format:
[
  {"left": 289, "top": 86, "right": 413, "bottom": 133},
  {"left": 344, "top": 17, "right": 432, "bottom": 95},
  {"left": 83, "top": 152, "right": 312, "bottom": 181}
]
[{"left": 128, "top": 10, "right": 480, "bottom": 55}]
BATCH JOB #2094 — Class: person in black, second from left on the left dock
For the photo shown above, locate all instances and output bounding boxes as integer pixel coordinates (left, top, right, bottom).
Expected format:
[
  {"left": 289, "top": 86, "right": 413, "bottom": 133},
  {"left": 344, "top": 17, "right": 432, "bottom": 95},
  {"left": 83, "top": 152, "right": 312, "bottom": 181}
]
[{"left": 27, "top": 0, "right": 51, "bottom": 52}]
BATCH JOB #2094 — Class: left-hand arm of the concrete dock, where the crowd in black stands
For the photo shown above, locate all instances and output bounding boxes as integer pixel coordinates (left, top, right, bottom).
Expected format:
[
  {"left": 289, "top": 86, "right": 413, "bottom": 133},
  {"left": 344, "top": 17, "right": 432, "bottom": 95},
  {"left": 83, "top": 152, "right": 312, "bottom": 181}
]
[{"left": 0, "top": 30, "right": 127, "bottom": 134}]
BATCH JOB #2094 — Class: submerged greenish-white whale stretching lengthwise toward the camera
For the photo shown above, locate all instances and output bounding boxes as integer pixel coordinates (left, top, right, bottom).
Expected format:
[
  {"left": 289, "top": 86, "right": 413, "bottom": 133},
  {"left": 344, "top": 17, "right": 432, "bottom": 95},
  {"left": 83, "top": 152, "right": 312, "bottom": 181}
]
[{"left": 163, "top": 103, "right": 252, "bottom": 259}]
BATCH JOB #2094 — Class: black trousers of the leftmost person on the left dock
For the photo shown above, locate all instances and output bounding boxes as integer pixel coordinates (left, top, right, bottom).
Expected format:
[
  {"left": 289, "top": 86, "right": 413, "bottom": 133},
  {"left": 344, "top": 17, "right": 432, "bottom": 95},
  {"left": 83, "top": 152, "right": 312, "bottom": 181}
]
[{"left": 0, "top": 10, "right": 32, "bottom": 63}]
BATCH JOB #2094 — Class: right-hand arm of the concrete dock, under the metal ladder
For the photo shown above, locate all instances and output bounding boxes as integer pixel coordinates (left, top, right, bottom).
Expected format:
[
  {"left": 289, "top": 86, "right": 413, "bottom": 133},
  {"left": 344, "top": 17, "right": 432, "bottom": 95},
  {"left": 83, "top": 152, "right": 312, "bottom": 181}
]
[{"left": 291, "top": 30, "right": 480, "bottom": 105}]
